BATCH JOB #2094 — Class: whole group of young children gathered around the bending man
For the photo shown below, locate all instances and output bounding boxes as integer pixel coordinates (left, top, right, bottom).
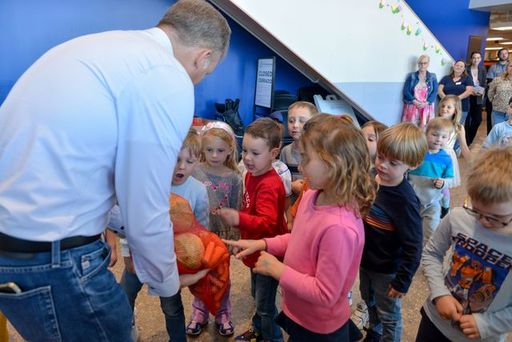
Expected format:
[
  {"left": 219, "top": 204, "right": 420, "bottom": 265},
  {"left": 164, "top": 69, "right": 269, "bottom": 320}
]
[{"left": 110, "top": 96, "right": 512, "bottom": 341}]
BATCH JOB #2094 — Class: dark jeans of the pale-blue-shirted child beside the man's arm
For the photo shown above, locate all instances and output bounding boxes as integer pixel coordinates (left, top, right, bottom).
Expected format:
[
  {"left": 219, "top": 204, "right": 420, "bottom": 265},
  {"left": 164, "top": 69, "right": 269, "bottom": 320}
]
[{"left": 121, "top": 268, "right": 187, "bottom": 342}]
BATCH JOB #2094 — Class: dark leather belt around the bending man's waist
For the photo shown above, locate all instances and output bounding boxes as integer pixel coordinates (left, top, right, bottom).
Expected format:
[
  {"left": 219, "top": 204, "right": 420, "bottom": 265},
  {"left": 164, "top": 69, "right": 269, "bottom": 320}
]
[{"left": 0, "top": 233, "right": 101, "bottom": 253}]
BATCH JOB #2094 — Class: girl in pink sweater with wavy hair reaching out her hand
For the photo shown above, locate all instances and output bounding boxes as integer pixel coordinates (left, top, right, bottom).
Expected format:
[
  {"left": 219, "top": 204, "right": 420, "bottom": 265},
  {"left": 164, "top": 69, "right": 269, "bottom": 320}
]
[{"left": 225, "top": 114, "right": 375, "bottom": 341}]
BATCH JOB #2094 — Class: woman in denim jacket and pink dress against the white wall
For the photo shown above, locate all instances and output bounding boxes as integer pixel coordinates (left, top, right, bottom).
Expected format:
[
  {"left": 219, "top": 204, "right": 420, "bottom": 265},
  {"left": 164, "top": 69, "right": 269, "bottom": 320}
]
[{"left": 402, "top": 55, "right": 437, "bottom": 129}]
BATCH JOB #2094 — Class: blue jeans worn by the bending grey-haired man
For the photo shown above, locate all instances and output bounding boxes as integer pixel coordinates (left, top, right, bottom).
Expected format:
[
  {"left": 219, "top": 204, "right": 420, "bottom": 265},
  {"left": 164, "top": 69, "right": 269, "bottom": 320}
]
[{"left": 0, "top": 241, "right": 132, "bottom": 342}]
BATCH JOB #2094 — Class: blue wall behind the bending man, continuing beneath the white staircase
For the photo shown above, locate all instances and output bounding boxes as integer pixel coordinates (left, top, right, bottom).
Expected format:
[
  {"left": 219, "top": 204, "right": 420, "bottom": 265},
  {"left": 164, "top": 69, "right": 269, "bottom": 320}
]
[{"left": 0, "top": 0, "right": 311, "bottom": 123}]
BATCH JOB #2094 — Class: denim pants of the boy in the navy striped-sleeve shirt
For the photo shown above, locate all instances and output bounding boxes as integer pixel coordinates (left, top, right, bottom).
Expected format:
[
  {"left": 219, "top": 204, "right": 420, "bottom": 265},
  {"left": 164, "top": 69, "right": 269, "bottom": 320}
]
[{"left": 359, "top": 267, "right": 402, "bottom": 342}]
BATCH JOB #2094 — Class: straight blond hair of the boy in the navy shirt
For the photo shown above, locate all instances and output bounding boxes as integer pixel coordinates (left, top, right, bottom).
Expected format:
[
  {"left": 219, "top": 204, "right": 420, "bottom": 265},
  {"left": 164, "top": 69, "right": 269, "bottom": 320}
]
[{"left": 377, "top": 122, "right": 428, "bottom": 167}]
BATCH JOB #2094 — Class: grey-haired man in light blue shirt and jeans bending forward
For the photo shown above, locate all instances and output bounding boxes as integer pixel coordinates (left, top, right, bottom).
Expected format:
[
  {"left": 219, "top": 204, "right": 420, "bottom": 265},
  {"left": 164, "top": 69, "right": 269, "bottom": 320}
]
[{"left": 0, "top": 0, "right": 231, "bottom": 342}]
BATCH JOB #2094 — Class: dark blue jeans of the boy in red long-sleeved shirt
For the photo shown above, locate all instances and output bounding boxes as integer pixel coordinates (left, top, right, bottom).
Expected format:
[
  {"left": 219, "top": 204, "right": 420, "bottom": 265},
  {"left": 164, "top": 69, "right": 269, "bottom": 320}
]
[{"left": 251, "top": 270, "right": 283, "bottom": 342}]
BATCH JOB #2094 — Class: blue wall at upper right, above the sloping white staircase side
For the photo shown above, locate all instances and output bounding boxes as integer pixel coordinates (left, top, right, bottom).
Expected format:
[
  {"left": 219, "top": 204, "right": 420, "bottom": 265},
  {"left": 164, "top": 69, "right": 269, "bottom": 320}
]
[{"left": 406, "top": 0, "right": 490, "bottom": 60}]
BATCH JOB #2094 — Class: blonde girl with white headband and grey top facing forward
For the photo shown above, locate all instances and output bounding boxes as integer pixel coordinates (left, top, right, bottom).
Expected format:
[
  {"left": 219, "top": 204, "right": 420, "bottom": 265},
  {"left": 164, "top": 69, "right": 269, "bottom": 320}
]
[{"left": 187, "top": 121, "right": 242, "bottom": 336}]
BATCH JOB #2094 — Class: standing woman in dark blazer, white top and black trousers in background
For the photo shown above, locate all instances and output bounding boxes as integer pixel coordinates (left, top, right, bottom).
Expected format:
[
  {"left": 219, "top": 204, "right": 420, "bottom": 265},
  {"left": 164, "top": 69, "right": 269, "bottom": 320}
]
[{"left": 465, "top": 51, "right": 487, "bottom": 146}]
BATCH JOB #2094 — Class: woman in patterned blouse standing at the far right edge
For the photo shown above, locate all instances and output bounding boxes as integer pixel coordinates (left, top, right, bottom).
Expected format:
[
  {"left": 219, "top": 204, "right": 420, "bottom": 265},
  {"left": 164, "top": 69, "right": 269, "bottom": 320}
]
[{"left": 487, "top": 63, "right": 512, "bottom": 127}]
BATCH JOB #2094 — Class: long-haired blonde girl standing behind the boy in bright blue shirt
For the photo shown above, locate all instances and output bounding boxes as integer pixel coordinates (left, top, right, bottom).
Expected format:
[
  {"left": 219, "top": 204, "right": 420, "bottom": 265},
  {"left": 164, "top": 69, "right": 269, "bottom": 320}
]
[{"left": 437, "top": 95, "right": 471, "bottom": 217}]
